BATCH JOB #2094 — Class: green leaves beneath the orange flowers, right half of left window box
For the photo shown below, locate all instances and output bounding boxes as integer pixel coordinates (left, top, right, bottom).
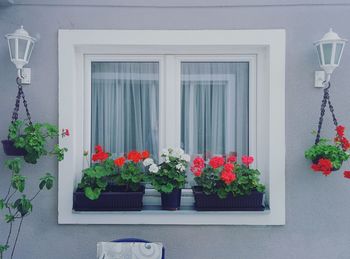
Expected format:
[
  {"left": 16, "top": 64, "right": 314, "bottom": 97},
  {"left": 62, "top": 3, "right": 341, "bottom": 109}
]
[{"left": 114, "top": 161, "right": 145, "bottom": 191}]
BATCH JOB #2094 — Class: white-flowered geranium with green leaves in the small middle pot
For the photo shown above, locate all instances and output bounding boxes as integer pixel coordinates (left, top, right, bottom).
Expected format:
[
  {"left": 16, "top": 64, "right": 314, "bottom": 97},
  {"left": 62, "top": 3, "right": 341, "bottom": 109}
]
[{"left": 145, "top": 148, "right": 190, "bottom": 193}]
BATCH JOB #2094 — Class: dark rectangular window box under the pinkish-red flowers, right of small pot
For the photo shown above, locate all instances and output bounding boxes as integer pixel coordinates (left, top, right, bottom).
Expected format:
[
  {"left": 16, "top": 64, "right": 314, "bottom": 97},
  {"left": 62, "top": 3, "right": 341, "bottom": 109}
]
[{"left": 192, "top": 186, "right": 265, "bottom": 211}]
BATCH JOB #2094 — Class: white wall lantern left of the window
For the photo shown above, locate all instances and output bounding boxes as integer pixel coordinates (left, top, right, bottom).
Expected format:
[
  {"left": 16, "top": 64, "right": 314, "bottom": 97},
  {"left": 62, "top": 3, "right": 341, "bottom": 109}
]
[{"left": 5, "top": 26, "right": 36, "bottom": 84}]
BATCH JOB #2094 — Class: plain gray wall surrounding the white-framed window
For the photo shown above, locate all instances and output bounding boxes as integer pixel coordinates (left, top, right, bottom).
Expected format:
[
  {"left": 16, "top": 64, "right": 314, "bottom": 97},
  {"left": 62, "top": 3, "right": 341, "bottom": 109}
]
[{"left": 0, "top": 0, "right": 350, "bottom": 259}]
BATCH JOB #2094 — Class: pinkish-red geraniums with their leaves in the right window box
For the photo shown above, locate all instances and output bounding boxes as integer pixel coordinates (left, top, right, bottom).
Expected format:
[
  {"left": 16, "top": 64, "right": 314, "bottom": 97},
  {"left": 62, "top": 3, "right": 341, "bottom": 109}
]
[{"left": 191, "top": 156, "right": 265, "bottom": 199}]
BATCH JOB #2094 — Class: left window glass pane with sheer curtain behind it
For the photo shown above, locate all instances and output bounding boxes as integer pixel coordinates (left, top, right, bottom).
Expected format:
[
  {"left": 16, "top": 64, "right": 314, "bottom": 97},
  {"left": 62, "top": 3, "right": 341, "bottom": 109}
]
[{"left": 91, "top": 62, "right": 159, "bottom": 158}]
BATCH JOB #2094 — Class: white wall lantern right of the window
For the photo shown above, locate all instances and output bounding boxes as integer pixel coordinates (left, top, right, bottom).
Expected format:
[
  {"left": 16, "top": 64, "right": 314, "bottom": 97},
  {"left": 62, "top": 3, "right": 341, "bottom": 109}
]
[{"left": 314, "top": 29, "right": 347, "bottom": 87}]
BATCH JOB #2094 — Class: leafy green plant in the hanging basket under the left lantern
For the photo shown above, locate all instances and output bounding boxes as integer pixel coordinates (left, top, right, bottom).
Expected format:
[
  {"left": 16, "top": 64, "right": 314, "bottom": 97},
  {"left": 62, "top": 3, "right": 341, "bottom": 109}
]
[{"left": 8, "top": 120, "right": 69, "bottom": 164}]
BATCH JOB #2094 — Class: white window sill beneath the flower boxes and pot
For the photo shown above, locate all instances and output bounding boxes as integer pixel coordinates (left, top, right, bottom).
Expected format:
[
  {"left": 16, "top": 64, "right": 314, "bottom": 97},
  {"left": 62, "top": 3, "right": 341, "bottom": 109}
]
[{"left": 59, "top": 206, "right": 285, "bottom": 225}]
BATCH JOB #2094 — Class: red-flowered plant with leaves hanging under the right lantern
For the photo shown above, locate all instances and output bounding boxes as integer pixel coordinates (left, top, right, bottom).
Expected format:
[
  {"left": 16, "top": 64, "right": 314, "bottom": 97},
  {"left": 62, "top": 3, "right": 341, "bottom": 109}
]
[{"left": 305, "top": 125, "right": 350, "bottom": 176}]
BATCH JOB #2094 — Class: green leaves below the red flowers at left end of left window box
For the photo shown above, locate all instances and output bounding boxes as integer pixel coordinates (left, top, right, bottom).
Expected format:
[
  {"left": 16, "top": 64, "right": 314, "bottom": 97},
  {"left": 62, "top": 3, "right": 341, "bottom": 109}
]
[{"left": 78, "top": 159, "right": 116, "bottom": 200}]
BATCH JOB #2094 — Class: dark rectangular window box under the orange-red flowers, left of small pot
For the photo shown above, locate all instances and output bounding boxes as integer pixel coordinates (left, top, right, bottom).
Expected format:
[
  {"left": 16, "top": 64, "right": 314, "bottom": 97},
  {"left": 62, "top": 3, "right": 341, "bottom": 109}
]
[{"left": 73, "top": 186, "right": 145, "bottom": 211}]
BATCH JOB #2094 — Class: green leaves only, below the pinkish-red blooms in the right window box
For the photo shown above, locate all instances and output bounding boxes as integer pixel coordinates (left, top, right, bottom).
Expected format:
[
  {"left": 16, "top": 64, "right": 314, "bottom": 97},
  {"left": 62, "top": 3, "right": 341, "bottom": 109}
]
[{"left": 194, "top": 163, "right": 265, "bottom": 199}]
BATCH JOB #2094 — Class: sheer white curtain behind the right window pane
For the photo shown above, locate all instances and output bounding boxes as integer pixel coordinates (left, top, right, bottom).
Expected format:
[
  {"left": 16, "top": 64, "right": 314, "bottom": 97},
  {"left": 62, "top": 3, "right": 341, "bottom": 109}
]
[{"left": 181, "top": 62, "right": 249, "bottom": 155}]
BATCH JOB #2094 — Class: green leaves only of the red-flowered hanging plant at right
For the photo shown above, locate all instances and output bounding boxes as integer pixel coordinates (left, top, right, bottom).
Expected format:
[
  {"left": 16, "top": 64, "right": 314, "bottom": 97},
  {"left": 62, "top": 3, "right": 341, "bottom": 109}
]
[{"left": 305, "top": 139, "right": 350, "bottom": 170}]
